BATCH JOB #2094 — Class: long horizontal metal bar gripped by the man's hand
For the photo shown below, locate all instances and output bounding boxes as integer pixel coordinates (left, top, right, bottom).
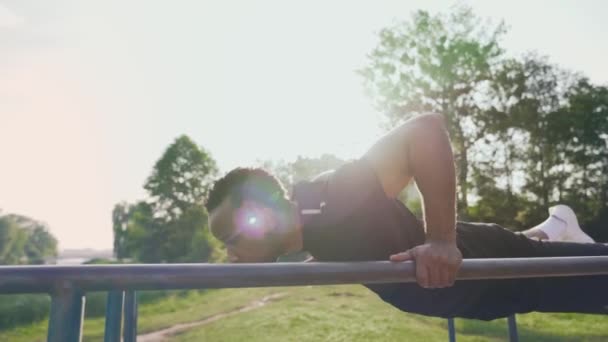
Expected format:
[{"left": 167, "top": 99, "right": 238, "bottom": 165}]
[{"left": 0, "top": 256, "right": 608, "bottom": 293}]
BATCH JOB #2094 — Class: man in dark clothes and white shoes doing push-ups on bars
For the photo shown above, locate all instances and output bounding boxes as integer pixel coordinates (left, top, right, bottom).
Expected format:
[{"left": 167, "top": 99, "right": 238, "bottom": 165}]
[{"left": 207, "top": 114, "right": 608, "bottom": 320}]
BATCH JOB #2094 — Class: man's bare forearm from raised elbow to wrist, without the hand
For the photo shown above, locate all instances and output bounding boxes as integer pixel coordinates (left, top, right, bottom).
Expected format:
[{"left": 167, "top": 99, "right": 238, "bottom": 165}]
[{"left": 408, "top": 116, "right": 456, "bottom": 242}]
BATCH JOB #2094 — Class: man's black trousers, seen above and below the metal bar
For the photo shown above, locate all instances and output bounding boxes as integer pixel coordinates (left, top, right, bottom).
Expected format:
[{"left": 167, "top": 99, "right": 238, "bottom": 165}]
[{"left": 368, "top": 222, "right": 608, "bottom": 320}]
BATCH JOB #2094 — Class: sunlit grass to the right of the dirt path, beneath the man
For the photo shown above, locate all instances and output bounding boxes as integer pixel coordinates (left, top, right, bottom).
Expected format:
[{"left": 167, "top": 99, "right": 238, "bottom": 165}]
[{"left": 175, "top": 285, "right": 608, "bottom": 342}]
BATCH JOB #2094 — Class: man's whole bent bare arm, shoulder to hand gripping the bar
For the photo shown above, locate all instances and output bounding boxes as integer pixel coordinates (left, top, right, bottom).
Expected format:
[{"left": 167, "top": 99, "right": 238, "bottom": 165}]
[{"left": 365, "top": 114, "right": 462, "bottom": 288}]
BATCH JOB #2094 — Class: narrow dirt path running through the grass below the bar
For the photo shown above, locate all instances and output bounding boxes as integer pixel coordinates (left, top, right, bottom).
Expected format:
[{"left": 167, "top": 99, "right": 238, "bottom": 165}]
[{"left": 137, "top": 293, "right": 286, "bottom": 342}]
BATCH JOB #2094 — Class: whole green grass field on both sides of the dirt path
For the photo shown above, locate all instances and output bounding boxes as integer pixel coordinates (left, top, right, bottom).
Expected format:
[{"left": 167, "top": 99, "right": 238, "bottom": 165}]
[{"left": 0, "top": 285, "right": 608, "bottom": 342}]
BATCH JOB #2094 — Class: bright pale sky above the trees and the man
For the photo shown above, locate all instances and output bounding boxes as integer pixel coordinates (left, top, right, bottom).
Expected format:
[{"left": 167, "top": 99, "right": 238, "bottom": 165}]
[{"left": 0, "top": 0, "right": 608, "bottom": 248}]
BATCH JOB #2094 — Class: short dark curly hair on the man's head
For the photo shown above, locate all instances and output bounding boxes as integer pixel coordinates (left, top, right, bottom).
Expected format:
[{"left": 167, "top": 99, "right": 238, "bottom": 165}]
[{"left": 205, "top": 167, "right": 287, "bottom": 212}]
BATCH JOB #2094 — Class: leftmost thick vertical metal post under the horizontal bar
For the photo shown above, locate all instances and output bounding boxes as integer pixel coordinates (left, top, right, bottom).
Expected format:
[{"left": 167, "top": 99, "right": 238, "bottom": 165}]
[{"left": 47, "top": 285, "right": 85, "bottom": 342}]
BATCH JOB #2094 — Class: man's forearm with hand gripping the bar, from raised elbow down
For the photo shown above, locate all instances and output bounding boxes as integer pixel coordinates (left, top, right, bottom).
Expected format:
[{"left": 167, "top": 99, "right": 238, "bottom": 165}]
[{"left": 390, "top": 115, "right": 462, "bottom": 288}]
